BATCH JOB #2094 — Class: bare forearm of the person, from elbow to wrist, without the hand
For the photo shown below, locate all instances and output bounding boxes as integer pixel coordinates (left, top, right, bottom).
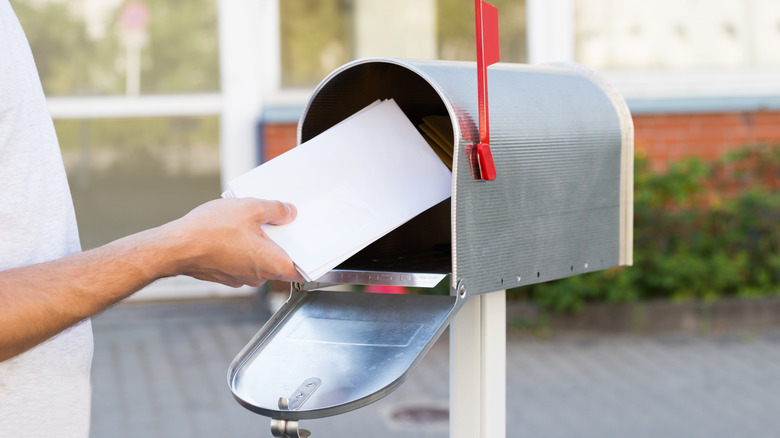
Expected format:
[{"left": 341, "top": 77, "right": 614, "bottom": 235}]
[{"left": 0, "top": 222, "right": 186, "bottom": 361}]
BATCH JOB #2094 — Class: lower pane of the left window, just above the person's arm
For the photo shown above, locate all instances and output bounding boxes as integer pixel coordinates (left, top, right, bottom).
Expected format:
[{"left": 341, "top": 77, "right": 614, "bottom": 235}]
[{"left": 55, "top": 116, "right": 220, "bottom": 249}]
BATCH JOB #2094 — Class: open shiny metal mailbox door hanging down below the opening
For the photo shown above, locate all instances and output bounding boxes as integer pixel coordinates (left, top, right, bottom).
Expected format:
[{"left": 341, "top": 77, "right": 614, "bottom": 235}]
[{"left": 228, "top": 290, "right": 464, "bottom": 420}]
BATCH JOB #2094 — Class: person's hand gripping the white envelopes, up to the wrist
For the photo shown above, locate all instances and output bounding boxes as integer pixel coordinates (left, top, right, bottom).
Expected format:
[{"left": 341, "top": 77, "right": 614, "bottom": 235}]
[{"left": 164, "top": 198, "right": 303, "bottom": 287}]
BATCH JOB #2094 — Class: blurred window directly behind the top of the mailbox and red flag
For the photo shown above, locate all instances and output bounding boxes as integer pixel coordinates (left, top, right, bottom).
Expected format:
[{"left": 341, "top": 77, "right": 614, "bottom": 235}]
[{"left": 280, "top": 0, "right": 526, "bottom": 88}]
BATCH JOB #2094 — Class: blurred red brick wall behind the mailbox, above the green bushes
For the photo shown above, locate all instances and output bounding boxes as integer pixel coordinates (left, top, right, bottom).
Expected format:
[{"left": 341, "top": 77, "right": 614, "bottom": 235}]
[{"left": 263, "top": 111, "right": 780, "bottom": 171}]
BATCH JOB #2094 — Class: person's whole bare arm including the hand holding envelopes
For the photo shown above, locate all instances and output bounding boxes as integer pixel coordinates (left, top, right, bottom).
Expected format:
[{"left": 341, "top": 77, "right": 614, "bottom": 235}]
[{"left": 0, "top": 199, "right": 302, "bottom": 361}]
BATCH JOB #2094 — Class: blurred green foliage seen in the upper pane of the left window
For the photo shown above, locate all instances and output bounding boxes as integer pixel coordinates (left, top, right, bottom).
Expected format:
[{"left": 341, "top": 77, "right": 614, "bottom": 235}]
[{"left": 14, "top": 0, "right": 219, "bottom": 96}]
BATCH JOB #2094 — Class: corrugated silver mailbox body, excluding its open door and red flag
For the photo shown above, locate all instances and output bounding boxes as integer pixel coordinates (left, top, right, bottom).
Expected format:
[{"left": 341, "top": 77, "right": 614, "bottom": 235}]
[{"left": 298, "top": 58, "right": 633, "bottom": 295}]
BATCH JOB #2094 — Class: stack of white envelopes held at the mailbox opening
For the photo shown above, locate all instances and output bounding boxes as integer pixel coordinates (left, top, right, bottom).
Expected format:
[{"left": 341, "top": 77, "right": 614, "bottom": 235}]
[{"left": 223, "top": 100, "right": 452, "bottom": 281}]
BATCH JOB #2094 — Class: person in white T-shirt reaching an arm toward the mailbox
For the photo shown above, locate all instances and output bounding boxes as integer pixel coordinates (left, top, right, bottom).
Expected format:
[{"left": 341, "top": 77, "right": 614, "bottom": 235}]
[{"left": 0, "top": 0, "right": 302, "bottom": 437}]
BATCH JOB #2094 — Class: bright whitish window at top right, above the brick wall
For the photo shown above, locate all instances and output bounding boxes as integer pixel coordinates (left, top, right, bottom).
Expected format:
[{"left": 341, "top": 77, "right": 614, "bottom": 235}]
[{"left": 574, "top": 0, "right": 780, "bottom": 69}]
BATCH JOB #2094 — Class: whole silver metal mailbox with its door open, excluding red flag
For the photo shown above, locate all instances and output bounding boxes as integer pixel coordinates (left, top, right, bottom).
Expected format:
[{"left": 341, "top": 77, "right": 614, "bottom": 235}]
[{"left": 228, "top": 58, "right": 633, "bottom": 428}]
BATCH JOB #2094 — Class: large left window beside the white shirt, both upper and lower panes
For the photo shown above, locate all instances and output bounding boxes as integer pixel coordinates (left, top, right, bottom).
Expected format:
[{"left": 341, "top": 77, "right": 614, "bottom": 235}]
[{"left": 13, "top": 0, "right": 220, "bottom": 249}]
